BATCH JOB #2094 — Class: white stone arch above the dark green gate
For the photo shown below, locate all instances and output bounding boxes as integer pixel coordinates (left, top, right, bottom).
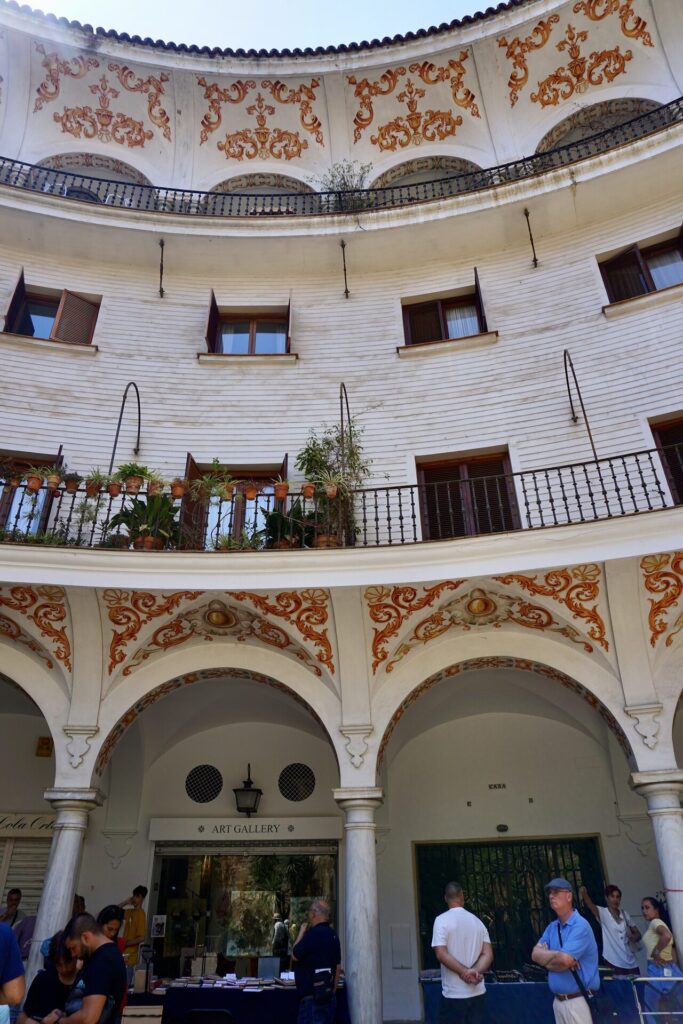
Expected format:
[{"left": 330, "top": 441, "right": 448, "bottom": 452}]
[{"left": 373, "top": 630, "right": 652, "bottom": 771}]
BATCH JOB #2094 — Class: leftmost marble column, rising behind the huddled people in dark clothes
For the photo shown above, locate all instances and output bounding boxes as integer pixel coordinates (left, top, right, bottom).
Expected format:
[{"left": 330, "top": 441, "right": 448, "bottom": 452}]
[{"left": 27, "top": 790, "right": 102, "bottom": 987}]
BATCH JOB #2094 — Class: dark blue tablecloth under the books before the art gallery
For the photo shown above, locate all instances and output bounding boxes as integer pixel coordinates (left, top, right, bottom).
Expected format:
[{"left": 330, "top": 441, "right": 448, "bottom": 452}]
[{"left": 162, "top": 987, "right": 350, "bottom": 1024}]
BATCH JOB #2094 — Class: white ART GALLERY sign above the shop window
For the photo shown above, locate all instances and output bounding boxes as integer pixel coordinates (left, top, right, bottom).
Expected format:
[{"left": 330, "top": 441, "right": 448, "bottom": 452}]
[{"left": 150, "top": 817, "right": 342, "bottom": 843}]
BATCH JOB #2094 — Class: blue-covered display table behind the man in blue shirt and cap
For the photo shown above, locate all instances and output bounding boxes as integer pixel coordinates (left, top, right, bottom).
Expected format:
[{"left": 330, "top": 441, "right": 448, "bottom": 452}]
[{"left": 421, "top": 980, "right": 642, "bottom": 1024}]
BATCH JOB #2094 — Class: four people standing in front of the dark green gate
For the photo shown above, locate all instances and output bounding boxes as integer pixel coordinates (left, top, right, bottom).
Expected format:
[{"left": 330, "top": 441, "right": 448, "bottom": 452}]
[{"left": 432, "top": 878, "right": 683, "bottom": 1024}]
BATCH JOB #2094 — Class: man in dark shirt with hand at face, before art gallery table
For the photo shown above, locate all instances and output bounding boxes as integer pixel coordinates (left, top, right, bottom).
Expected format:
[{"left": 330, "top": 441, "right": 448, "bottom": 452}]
[{"left": 292, "top": 899, "right": 341, "bottom": 1024}]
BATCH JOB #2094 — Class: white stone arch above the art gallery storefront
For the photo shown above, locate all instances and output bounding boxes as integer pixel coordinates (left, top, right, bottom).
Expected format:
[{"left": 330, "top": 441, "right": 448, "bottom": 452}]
[{"left": 92, "top": 641, "right": 343, "bottom": 777}]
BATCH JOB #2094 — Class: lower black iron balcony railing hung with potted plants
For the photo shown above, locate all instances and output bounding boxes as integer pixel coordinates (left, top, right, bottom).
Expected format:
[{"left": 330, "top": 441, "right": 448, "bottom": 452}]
[{"left": 0, "top": 444, "right": 683, "bottom": 551}]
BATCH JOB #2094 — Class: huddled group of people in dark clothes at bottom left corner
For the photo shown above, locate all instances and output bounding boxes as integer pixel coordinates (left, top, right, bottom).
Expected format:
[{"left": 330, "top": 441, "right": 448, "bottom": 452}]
[{"left": 0, "top": 886, "right": 147, "bottom": 1024}]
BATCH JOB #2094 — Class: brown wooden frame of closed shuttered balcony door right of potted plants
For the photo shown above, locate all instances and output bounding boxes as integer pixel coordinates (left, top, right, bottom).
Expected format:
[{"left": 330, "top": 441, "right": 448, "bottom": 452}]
[{"left": 417, "top": 450, "right": 521, "bottom": 541}]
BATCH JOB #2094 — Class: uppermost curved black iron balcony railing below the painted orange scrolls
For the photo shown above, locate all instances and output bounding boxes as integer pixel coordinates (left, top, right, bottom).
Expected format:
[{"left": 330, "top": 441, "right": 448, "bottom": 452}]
[{"left": 0, "top": 97, "right": 683, "bottom": 217}]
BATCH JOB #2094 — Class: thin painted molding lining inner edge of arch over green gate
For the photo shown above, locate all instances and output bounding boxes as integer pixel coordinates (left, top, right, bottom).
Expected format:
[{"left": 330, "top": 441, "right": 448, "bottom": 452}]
[{"left": 377, "top": 654, "right": 637, "bottom": 772}]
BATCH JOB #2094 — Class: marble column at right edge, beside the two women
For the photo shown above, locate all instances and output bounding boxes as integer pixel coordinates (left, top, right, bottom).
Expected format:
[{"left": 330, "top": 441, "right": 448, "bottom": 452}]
[{"left": 631, "top": 768, "right": 683, "bottom": 948}]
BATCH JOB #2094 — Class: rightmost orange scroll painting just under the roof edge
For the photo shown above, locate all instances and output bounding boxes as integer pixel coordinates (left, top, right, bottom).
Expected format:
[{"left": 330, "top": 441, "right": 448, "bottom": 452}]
[{"left": 498, "top": 0, "right": 654, "bottom": 106}]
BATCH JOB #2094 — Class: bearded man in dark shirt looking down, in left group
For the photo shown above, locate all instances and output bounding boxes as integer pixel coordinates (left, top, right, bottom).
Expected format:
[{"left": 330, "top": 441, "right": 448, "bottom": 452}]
[{"left": 63, "top": 913, "right": 127, "bottom": 1024}]
